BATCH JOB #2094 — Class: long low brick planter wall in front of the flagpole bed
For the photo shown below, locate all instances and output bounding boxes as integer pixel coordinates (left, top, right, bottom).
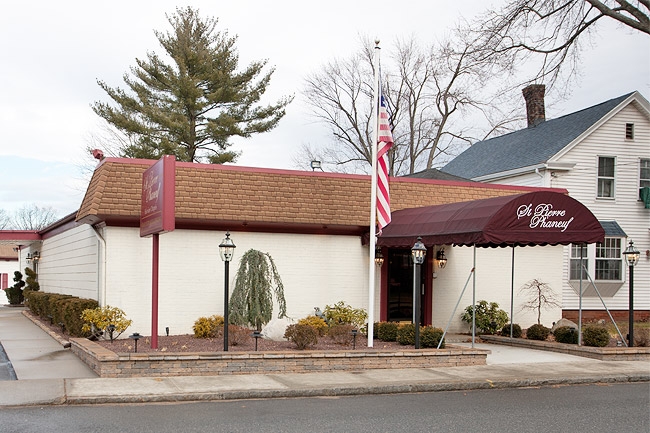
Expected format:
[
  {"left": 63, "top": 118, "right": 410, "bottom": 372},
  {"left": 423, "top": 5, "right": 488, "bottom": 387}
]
[{"left": 70, "top": 338, "right": 489, "bottom": 377}]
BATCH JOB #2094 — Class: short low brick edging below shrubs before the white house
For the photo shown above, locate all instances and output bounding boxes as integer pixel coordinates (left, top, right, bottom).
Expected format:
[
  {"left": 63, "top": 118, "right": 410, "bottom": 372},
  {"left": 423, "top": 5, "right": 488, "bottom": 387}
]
[{"left": 480, "top": 335, "right": 650, "bottom": 361}]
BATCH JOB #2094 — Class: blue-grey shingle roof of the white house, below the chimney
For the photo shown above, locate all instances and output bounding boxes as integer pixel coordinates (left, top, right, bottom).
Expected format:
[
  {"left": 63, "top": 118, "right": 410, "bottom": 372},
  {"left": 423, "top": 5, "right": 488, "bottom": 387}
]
[{"left": 441, "top": 93, "right": 632, "bottom": 179}]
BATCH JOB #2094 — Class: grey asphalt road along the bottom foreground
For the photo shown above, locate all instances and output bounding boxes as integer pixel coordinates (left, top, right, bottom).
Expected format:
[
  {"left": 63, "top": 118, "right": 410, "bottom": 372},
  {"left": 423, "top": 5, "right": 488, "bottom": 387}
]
[{"left": 0, "top": 383, "right": 650, "bottom": 433}]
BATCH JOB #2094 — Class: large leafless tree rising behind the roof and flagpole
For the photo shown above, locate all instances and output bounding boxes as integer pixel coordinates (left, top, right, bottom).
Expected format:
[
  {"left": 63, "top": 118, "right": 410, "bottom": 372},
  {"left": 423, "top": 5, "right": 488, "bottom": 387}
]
[{"left": 303, "top": 30, "right": 510, "bottom": 175}]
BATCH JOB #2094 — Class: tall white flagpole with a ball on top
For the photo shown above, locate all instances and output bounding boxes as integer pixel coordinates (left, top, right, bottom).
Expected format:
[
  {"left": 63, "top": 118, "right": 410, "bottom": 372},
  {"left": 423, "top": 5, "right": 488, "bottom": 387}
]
[{"left": 368, "top": 40, "right": 380, "bottom": 347}]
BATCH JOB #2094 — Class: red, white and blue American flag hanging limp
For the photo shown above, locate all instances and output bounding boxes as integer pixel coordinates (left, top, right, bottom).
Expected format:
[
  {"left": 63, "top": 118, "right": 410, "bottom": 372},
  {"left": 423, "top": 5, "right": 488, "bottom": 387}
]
[{"left": 377, "top": 94, "right": 393, "bottom": 233}]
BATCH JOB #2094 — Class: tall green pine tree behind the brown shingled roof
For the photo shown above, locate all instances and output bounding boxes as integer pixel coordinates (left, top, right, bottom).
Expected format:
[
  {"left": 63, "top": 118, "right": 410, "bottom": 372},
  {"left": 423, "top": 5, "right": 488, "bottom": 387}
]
[{"left": 93, "top": 7, "right": 293, "bottom": 163}]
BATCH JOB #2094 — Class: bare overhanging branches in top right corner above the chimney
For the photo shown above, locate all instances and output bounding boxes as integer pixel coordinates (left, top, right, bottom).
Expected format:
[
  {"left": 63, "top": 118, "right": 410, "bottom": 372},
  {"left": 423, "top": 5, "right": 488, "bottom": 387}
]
[{"left": 470, "top": 0, "right": 650, "bottom": 87}]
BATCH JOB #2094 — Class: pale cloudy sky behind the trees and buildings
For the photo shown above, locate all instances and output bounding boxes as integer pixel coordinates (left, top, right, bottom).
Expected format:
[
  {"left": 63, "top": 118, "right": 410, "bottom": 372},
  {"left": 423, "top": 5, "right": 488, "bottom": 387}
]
[{"left": 0, "top": 0, "right": 650, "bottom": 216}]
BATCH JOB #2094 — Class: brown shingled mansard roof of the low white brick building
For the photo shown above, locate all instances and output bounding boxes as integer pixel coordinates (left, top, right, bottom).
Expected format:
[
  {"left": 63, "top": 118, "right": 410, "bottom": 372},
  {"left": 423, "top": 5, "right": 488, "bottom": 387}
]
[{"left": 76, "top": 158, "right": 552, "bottom": 234}]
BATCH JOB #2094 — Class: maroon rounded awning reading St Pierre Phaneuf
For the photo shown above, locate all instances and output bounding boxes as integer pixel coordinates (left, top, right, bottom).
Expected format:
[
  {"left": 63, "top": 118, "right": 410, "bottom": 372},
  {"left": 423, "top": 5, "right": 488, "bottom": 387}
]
[{"left": 377, "top": 191, "right": 605, "bottom": 247}]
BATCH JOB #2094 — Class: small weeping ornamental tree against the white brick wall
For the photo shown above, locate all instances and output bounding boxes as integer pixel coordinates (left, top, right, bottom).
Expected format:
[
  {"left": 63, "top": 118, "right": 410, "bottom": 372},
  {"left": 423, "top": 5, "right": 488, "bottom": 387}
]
[{"left": 229, "top": 249, "right": 287, "bottom": 331}]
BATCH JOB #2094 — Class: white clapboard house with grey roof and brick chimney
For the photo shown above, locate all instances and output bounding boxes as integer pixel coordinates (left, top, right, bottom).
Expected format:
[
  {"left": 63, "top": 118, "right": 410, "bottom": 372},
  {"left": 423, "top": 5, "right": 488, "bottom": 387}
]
[{"left": 442, "top": 85, "right": 650, "bottom": 320}]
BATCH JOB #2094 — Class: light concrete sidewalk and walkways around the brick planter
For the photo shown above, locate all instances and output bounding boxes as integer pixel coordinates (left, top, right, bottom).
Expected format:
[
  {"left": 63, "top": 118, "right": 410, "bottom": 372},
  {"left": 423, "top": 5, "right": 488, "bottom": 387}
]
[{"left": 0, "top": 307, "right": 650, "bottom": 406}]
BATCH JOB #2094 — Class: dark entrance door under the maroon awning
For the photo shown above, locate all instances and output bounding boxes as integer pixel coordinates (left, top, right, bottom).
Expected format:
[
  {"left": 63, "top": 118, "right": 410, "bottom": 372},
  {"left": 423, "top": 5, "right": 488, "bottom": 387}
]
[{"left": 386, "top": 249, "right": 428, "bottom": 324}]
